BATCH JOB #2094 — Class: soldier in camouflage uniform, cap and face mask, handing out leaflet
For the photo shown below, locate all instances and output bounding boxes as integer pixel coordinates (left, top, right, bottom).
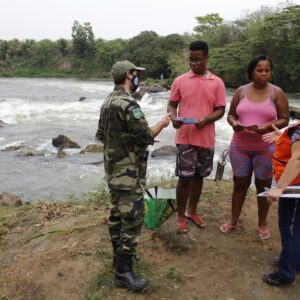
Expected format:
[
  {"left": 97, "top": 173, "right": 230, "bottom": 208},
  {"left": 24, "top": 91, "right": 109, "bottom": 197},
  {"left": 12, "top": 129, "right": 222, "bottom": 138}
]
[{"left": 96, "top": 60, "right": 170, "bottom": 290}]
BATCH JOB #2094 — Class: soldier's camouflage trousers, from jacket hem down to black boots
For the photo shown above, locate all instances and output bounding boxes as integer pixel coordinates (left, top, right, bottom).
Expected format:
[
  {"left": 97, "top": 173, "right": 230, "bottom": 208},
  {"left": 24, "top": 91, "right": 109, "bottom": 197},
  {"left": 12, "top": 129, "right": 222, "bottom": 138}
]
[{"left": 108, "top": 190, "right": 144, "bottom": 255}]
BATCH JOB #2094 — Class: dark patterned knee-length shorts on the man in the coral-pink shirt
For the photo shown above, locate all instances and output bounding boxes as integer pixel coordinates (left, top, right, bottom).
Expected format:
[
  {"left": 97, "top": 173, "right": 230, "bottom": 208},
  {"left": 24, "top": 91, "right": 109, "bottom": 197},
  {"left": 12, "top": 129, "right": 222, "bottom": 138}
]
[{"left": 175, "top": 144, "right": 214, "bottom": 177}]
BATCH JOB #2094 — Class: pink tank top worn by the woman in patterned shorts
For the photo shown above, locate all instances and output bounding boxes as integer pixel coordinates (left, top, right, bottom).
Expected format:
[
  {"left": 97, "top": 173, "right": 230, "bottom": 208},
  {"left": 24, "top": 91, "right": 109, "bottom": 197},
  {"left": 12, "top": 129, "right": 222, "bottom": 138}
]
[{"left": 232, "top": 84, "right": 277, "bottom": 151}]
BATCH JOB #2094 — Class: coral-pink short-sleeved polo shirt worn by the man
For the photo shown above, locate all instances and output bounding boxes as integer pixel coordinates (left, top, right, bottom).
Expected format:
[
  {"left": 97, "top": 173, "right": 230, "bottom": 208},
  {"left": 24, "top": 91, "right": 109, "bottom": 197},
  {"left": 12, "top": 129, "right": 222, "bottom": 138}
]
[{"left": 170, "top": 71, "right": 226, "bottom": 148}]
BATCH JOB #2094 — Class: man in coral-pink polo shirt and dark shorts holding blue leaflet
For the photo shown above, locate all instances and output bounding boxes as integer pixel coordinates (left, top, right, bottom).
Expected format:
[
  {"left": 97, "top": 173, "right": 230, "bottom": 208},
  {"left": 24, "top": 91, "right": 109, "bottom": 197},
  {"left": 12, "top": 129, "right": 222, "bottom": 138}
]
[{"left": 168, "top": 41, "right": 226, "bottom": 233}]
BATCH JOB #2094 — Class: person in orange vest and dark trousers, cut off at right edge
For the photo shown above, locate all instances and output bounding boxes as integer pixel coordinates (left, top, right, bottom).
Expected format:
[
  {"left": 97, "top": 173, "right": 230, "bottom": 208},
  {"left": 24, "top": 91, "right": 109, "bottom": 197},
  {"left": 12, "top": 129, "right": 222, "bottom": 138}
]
[{"left": 263, "top": 122, "right": 300, "bottom": 286}]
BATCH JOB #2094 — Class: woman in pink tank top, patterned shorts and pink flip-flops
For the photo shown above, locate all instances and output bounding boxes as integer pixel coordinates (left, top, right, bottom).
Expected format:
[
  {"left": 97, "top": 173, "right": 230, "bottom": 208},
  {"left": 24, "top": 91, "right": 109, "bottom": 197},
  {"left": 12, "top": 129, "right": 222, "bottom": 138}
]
[{"left": 220, "top": 55, "right": 289, "bottom": 239}]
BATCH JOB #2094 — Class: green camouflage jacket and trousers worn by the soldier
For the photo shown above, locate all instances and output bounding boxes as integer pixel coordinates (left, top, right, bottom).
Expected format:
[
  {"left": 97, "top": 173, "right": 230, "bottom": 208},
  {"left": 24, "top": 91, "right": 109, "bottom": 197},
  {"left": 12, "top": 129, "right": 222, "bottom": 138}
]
[{"left": 96, "top": 86, "right": 154, "bottom": 255}]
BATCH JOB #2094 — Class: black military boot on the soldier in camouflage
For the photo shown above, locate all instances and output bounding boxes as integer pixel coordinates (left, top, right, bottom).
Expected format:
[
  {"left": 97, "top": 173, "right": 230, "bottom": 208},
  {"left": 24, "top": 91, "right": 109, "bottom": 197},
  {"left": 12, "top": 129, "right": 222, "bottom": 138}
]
[{"left": 114, "top": 253, "right": 147, "bottom": 291}]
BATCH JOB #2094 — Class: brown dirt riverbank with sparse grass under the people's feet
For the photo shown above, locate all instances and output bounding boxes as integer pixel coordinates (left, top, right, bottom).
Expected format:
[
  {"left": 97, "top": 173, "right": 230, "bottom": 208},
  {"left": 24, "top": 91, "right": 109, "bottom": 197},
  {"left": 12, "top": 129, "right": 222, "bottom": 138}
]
[{"left": 0, "top": 181, "right": 300, "bottom": 300}]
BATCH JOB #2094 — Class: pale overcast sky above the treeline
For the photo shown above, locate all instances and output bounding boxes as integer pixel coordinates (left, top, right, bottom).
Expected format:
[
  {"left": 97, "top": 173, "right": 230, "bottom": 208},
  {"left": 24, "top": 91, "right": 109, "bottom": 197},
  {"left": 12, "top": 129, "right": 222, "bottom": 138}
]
[{"left": 0, "top": 0, "right": 300, "bottom": 41}]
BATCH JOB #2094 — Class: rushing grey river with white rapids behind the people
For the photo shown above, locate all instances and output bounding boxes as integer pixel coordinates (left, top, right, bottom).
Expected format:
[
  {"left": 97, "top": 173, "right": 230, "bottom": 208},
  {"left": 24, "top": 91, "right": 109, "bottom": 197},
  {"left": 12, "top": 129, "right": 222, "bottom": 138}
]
[{"left": 0, "top": 78, "right": 299, "bottom": 201}]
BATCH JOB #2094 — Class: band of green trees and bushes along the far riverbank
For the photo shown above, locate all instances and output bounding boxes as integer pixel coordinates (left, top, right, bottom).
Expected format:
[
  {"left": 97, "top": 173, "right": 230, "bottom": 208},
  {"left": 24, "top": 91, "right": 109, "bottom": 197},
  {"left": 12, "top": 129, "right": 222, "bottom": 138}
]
[{"left": 0, "top": 1, "right": 300, "bottom": 92}]
